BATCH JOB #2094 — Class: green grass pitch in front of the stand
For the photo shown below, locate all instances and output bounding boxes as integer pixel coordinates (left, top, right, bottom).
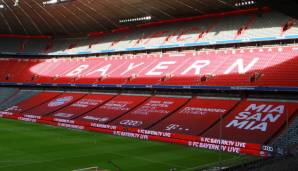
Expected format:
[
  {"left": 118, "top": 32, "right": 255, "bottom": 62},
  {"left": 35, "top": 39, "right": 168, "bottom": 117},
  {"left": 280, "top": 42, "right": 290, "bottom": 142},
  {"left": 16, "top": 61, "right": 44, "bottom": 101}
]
[{"left": 0, "top": 119, "right": 253, "bottom": 171}]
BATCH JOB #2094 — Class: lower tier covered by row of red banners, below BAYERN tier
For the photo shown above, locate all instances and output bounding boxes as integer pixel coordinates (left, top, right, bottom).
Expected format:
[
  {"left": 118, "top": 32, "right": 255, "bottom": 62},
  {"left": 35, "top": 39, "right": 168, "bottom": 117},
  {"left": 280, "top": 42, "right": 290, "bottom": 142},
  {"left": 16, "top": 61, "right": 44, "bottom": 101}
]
[{"left": 0, "top": 90, "right": 298, "bottom": 144}]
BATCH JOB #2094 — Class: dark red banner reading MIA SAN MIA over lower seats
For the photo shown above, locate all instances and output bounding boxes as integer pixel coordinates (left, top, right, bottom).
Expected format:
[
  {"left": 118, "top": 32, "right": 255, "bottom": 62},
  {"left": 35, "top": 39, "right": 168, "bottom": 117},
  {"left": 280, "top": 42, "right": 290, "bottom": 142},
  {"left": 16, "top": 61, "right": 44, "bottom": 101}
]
[{"left": 203, "top": 99, "right": 298, "bottom": 144}]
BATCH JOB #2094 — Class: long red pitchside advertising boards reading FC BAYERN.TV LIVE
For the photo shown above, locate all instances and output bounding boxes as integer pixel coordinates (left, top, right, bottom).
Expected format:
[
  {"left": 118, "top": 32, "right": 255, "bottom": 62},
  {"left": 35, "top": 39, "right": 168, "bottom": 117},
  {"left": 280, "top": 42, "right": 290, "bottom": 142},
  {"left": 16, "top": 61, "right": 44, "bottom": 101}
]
[{"left": 0, "top": 114, "right": 270, "bottom": 157}]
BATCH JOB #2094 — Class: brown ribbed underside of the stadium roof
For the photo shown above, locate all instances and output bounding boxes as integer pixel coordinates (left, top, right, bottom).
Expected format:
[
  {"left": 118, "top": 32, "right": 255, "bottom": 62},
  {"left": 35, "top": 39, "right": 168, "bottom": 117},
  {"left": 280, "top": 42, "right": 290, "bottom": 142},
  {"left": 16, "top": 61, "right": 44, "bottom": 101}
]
[{"left": 0, "top": 0, "right": 251, "bottom": 35}]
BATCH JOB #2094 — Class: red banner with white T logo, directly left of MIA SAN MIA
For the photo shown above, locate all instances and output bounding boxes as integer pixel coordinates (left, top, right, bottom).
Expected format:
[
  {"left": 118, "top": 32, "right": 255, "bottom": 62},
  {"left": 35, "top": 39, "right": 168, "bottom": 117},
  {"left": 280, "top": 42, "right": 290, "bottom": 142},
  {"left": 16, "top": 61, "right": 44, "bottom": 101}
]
[{"left": 150, "top": 97, "right": 240, "bottom": 135}]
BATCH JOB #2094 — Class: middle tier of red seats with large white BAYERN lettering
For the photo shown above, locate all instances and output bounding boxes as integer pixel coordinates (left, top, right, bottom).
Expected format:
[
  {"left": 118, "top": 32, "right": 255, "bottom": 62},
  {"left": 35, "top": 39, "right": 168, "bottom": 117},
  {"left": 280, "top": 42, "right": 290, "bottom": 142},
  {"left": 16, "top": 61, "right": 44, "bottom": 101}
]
[{"left": 0, "top": 46, "right": 298, "bottom": 87}]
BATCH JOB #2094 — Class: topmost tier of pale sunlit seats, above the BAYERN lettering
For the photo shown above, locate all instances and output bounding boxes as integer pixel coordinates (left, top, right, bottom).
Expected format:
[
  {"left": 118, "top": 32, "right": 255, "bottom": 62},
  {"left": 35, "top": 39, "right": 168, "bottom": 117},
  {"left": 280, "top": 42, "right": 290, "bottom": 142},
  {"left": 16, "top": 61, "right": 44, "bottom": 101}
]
[{"left": 0, "top": 12, "right": 298, "bottom": 55}]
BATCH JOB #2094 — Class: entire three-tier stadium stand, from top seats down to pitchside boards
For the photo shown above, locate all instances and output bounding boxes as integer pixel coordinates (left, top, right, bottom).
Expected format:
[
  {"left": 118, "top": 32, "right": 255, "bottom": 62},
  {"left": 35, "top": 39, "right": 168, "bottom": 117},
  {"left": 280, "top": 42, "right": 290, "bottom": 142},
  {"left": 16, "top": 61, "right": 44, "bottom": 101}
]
[{"left": 0, "top": 5, "right": 298, "bottom": 161}]
